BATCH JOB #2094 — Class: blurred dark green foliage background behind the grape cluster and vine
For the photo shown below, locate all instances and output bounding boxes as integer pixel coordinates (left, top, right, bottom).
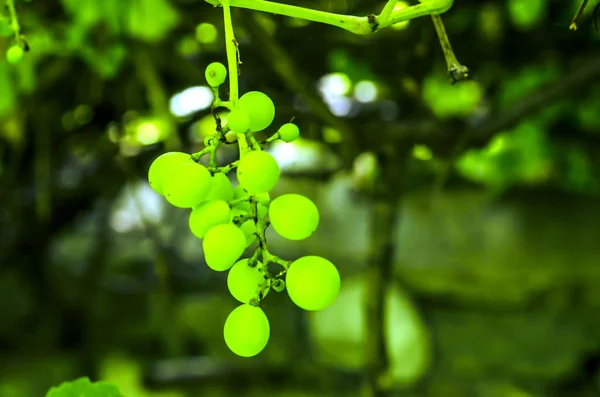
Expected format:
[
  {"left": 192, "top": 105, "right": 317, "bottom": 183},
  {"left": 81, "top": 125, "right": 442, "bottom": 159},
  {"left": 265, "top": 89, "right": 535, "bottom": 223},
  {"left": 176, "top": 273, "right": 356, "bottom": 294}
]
[{"left": 0, "top": 0, "right": 600, "bottom": 397}]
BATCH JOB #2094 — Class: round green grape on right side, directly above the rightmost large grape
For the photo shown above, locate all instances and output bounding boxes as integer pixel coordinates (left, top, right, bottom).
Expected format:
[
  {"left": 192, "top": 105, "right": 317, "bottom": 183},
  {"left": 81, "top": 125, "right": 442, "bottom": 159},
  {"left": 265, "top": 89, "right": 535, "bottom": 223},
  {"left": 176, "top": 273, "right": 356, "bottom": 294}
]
[{"left": 269, "top": 194, "right": 319, "bottom": 240}]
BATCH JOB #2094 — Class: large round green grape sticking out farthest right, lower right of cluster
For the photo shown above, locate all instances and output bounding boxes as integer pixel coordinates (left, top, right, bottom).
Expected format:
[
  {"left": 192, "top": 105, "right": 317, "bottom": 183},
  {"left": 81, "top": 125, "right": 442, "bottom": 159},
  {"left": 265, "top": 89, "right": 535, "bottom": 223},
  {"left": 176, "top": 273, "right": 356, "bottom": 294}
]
[{"left": 285, "top": 256, "right": 340, "bottom": 310}]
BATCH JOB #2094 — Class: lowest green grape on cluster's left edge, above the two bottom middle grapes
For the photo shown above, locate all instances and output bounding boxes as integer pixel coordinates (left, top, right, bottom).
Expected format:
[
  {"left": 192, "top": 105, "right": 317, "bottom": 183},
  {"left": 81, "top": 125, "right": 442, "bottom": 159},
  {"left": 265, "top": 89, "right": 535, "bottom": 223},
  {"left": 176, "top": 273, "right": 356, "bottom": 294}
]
[{"left": 202, "top": 223, "right": 246, "bottom": 272}]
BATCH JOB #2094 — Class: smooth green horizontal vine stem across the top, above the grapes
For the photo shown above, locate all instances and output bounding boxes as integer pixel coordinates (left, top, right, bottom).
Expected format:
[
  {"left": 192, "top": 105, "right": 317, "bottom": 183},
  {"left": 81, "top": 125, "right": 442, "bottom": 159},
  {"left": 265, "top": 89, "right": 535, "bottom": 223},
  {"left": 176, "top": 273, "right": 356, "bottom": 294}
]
[{"left": 205, "top": 0, "right": 454, "bottom": 35}]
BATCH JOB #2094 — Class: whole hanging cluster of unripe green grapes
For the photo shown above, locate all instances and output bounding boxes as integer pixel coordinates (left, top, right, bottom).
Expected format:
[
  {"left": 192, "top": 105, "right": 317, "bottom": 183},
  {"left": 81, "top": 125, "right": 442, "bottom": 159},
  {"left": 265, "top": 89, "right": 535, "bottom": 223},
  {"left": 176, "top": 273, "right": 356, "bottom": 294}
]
[{"left": 148, "top": 62, "right": 340, "bottom": 357}]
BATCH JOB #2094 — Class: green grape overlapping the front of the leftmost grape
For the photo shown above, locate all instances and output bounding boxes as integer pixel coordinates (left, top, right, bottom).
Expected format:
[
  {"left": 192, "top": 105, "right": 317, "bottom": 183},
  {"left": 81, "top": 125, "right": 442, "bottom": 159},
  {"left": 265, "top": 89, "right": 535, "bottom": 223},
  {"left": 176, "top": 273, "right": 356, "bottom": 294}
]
[{"left": 164, "top": 161, "right": 210, "bottom": 208}]
